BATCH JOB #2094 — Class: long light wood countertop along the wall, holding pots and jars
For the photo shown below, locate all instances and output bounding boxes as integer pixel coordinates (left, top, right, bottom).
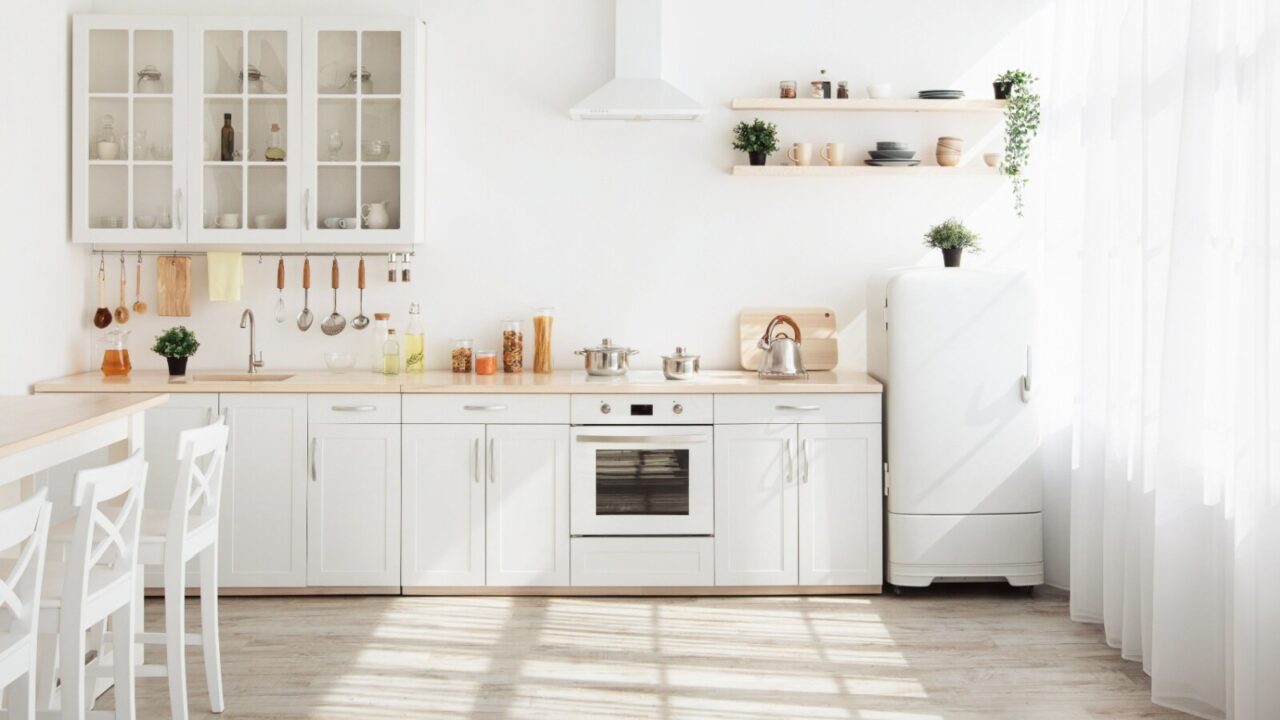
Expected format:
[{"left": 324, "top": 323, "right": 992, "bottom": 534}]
[{"left": 36, "top": 369, "right": 884, "bottom": 395}]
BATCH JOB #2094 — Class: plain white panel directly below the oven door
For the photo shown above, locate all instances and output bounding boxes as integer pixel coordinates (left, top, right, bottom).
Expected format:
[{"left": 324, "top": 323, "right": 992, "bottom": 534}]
[{"left": 570, "top": 537, "right": 716, "bottom": 587}]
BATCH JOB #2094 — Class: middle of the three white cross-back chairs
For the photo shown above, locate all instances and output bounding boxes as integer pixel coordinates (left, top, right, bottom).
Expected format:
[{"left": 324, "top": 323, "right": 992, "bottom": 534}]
[{"left": 37, "top": 450, "right": 147, "bottom": 720}]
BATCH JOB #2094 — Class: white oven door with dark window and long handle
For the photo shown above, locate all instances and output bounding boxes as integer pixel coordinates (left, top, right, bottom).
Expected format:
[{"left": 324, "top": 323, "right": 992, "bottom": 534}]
[{"left": 570, "top": 425, "right": 714, "bottom": 536}]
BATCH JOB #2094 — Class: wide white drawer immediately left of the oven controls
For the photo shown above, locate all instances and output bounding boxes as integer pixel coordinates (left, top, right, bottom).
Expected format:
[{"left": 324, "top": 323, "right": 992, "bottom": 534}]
[{"left": 404, "top": 393, "right": 568, "bottom": 425}]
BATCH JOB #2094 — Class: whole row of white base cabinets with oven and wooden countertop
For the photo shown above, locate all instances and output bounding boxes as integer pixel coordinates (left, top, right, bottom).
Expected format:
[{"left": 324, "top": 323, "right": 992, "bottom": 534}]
[{"left": 36, "top": 369, "right": 884, "bottom": 594}]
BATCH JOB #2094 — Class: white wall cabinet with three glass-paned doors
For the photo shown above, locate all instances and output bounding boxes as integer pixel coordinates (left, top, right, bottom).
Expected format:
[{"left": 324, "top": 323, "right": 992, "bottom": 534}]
[{"left": 72, "top": 15, "right": 426, "bottom": 245}]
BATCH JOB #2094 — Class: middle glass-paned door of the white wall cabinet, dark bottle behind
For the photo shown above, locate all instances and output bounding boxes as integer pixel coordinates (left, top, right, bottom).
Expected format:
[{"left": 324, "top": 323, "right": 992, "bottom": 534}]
[{"left": 189, "top": 18, "right": 302, "bottom": 243}]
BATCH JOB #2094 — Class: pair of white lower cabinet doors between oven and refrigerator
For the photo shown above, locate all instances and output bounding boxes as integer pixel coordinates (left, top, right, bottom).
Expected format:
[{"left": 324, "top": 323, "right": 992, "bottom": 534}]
[{"left": 716, "top": 423, "right": 883, "bottom": 585}]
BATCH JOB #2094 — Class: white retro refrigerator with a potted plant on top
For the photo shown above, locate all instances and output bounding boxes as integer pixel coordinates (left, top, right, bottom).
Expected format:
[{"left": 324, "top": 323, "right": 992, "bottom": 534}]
[{"left": 867, "top": 268, "right": 1044, "bottom": 587}]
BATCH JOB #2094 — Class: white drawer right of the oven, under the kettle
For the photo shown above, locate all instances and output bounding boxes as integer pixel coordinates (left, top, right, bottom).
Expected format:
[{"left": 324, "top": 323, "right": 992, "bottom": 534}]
[{"left": 716, "top": 392, "right": 881, "bottom": 424}]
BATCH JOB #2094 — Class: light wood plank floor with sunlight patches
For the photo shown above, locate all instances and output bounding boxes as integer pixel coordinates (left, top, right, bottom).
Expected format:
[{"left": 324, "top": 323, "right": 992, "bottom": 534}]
[{"left": 99, "top": 588, "right": 1185, "bottom": 720}]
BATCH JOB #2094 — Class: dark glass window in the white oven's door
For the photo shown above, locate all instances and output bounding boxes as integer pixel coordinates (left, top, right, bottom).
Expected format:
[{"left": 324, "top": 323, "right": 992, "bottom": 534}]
[{"left": 595, "top": 448, "right": 689, "bottom": 515}]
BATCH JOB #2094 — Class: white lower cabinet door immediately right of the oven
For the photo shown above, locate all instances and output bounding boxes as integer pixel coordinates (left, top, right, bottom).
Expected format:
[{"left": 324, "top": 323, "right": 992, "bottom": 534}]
[{"left": 716, "top": 424, "right": 799, "bottom": 585}]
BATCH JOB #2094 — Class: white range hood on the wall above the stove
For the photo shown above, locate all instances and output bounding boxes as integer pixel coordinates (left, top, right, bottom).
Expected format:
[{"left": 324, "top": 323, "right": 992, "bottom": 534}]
[{"left": 568, "top": 0, "right": 707, "bottom": 120}]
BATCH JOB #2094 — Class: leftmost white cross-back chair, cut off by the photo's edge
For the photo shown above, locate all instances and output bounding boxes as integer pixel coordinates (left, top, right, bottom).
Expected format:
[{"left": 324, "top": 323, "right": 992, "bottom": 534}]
[{"left": 0, "top": 488, "right": 52, "bottom": 720}]
